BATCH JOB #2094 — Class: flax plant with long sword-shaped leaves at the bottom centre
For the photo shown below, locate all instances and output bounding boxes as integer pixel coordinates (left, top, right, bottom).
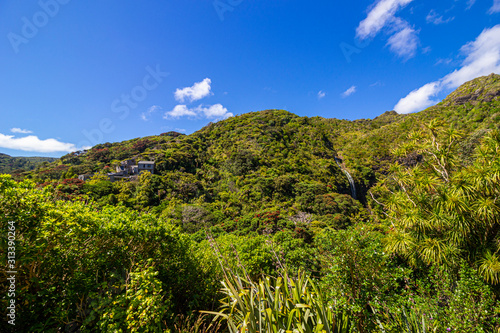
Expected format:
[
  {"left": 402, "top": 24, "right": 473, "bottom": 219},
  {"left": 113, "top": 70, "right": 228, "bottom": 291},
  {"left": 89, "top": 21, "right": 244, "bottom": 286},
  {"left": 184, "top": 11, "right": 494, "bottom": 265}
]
[{"left": 206, "top": 272, "right": 352, "bottom": 333}]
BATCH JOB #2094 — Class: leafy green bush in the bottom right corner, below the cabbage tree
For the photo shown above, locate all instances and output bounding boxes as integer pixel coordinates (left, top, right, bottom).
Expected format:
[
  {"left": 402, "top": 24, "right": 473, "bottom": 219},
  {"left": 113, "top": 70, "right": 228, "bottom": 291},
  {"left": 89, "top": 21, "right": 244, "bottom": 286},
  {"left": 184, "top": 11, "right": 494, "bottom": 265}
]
[{"left": 378, "top": 265, "right": 500, "bottom": 332}]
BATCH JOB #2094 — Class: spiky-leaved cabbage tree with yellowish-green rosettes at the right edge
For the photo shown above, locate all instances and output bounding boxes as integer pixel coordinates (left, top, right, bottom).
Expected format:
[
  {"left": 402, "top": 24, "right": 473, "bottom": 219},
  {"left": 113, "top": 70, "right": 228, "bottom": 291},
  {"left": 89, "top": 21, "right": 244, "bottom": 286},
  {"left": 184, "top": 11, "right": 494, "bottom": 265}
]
[{"left": 372, "top": 121, "right": 500, "bottom": 284}]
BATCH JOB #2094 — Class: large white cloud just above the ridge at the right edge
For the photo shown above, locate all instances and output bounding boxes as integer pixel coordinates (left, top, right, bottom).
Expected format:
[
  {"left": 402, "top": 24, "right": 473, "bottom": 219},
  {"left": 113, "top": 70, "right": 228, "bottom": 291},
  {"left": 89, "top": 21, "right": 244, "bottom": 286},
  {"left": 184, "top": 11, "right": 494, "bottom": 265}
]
[{"left": 394, "top": 24, "right": 500, "bottom": 113}]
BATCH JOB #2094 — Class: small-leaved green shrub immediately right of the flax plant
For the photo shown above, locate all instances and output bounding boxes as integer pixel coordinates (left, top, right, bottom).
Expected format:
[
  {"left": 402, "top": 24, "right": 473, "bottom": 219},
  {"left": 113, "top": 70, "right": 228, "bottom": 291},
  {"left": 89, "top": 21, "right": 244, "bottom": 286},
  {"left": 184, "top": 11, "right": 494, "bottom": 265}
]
[{"left": 317, "top": 225, "right": 410, "bottom": 332}]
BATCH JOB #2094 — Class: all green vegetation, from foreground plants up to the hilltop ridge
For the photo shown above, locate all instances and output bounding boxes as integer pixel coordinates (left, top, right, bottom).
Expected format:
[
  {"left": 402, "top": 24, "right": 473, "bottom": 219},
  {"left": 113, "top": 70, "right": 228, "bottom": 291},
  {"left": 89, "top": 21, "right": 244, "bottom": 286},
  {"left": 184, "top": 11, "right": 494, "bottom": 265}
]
[{"left": 0, "top": 74, "right": 500, "bottom": 332}]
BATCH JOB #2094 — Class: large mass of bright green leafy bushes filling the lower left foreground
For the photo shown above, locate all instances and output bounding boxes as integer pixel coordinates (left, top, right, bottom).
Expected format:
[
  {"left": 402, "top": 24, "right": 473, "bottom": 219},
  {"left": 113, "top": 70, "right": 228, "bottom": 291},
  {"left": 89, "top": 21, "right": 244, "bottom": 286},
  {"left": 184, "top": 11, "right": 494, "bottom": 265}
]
[{"left": 0, "top": 175, "right": 217, "bottom": 332}]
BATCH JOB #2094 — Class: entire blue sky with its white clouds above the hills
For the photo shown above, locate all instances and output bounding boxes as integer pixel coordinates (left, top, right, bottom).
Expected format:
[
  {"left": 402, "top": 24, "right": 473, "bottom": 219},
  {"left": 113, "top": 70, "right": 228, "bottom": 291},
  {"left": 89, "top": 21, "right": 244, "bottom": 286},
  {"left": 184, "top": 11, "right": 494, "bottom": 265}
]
[{"left": 0, "top": 0, "right": 500, "bottom": 157}]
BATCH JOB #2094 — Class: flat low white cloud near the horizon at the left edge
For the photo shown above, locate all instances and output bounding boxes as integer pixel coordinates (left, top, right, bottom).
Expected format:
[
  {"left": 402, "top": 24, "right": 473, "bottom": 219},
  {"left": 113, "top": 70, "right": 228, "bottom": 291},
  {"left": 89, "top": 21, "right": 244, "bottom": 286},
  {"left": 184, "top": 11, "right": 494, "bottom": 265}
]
[{"left": 0, "top": 133, "right": 84, "bottom": 153}]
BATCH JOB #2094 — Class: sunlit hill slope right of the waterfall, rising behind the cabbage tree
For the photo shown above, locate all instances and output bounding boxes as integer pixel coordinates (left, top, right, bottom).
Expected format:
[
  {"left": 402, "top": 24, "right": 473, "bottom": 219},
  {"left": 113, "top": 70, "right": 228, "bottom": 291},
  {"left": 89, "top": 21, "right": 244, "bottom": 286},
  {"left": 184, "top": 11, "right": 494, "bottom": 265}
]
[{"left": 342, "top": 74, "right": 500, "bottom": 189}]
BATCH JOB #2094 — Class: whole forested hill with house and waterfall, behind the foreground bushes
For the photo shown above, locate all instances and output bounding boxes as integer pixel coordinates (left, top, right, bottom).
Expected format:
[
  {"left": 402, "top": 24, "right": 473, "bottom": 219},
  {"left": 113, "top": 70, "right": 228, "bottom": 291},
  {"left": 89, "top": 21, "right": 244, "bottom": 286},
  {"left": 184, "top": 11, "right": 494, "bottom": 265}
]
[{"left": 19, "top": 75, "right": 500, "bottom": 233}]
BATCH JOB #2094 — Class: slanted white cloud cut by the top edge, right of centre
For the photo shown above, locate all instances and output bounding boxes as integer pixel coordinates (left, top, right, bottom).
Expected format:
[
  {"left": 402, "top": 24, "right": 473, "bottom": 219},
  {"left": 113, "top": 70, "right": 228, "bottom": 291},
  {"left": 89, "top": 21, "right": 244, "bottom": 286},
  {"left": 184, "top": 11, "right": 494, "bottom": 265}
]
[{"left": 356, "top": 0, "right": 413, "bottom": 39}]
